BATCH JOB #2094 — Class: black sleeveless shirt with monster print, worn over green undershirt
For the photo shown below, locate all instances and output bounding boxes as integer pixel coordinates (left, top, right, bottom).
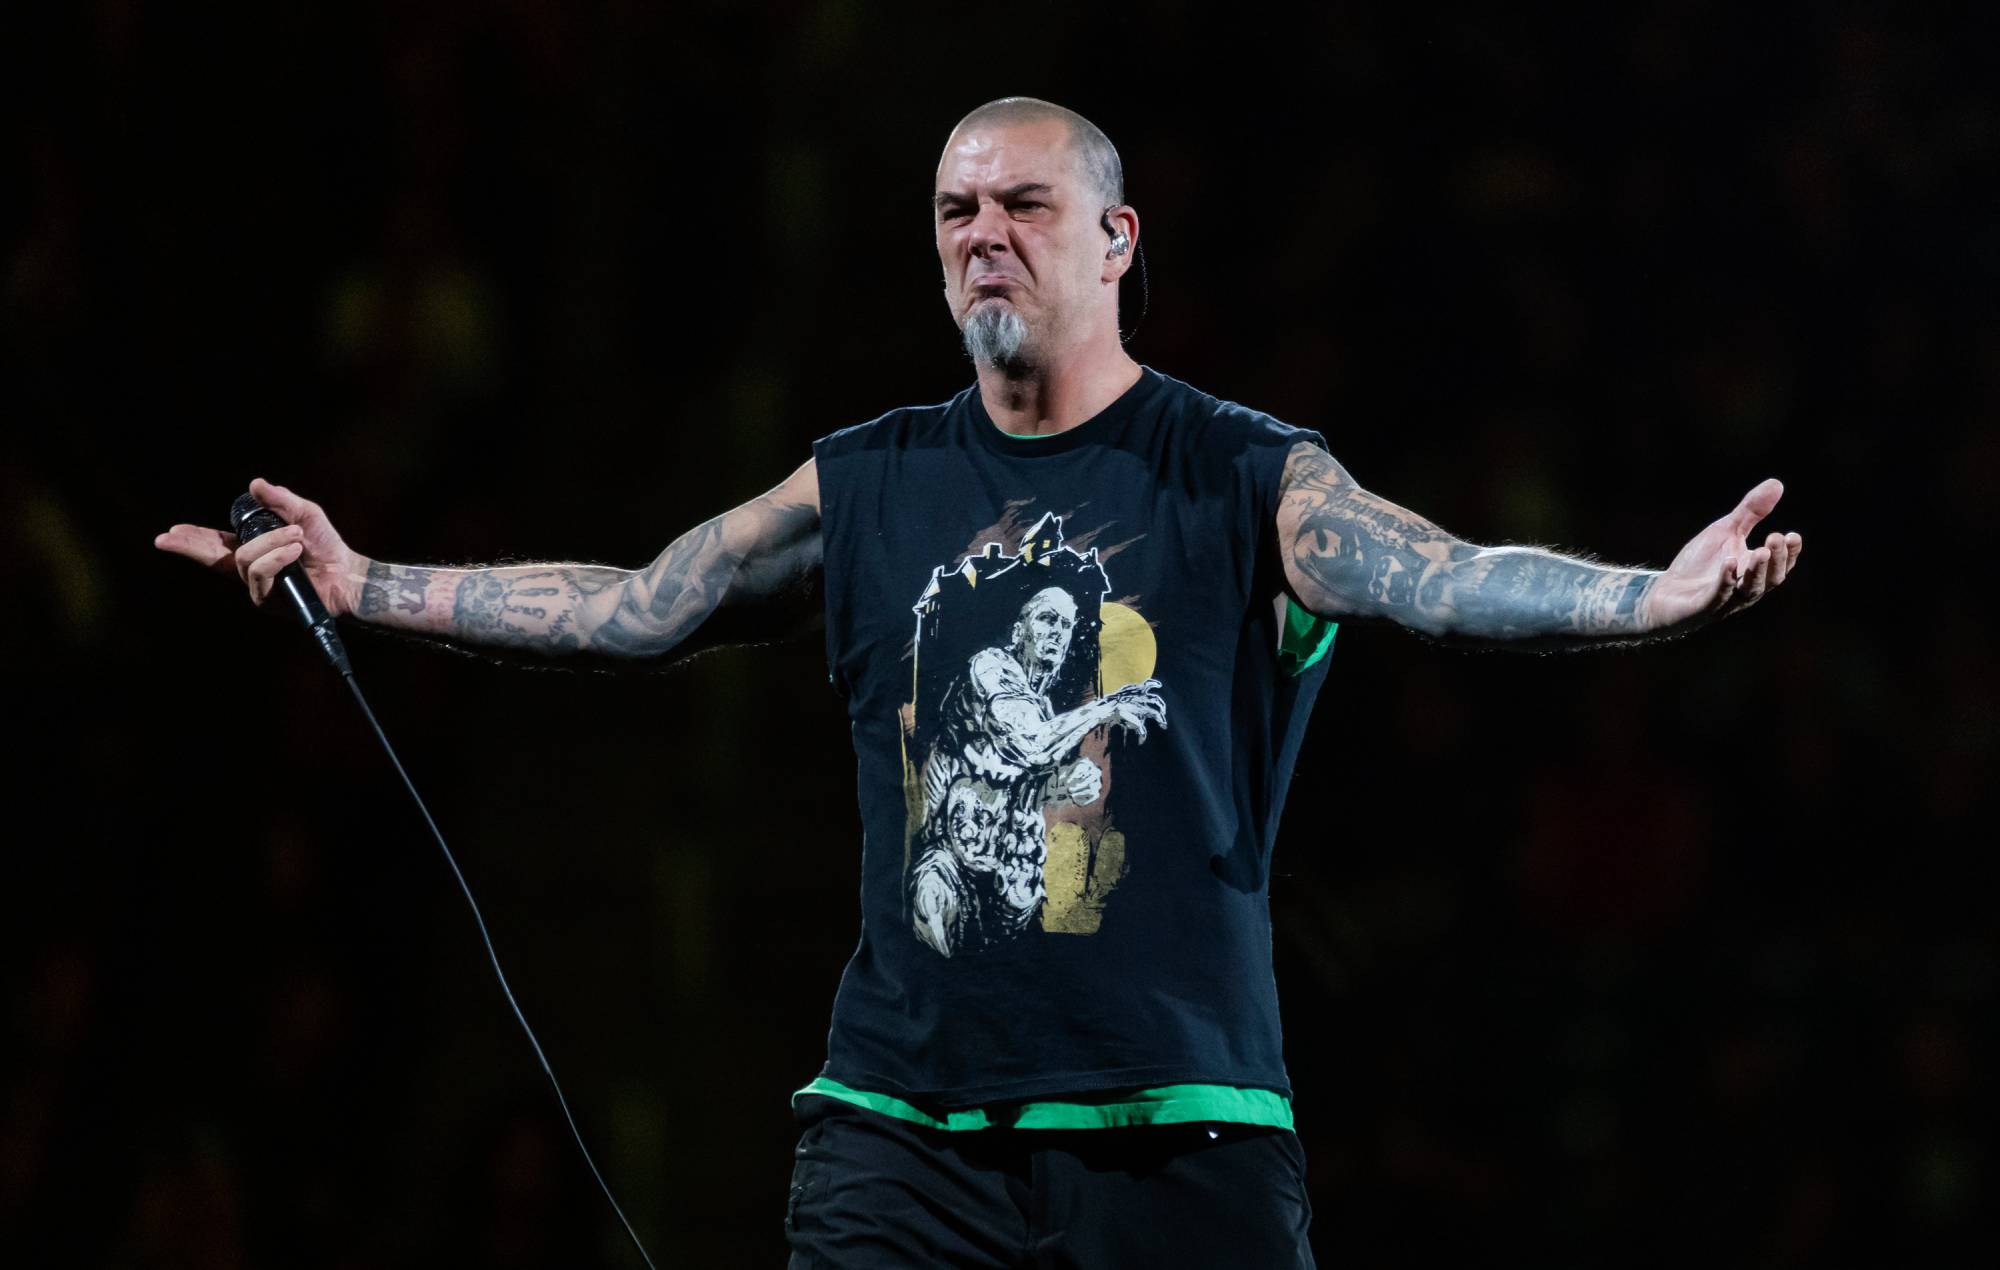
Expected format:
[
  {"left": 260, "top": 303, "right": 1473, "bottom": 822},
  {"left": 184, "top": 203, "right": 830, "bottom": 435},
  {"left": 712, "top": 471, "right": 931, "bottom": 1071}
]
[{"left": 814, "top": 370, "right": 1326, "bottom": 1108}]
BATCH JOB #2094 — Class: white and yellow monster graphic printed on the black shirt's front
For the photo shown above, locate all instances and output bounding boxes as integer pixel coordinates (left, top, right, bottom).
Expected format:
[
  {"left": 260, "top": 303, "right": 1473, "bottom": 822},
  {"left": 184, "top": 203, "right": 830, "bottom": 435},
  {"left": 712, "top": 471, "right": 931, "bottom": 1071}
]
[{"left": 902, "top": 500, "right": 1166, "bottom": 956}]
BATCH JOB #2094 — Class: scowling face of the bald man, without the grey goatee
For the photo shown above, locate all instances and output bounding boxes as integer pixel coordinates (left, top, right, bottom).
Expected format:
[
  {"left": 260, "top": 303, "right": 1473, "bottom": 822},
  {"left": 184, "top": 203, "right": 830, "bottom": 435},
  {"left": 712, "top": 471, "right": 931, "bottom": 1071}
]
[{"left": 934, "top": 120, "right": 1116, "bottom": 362}]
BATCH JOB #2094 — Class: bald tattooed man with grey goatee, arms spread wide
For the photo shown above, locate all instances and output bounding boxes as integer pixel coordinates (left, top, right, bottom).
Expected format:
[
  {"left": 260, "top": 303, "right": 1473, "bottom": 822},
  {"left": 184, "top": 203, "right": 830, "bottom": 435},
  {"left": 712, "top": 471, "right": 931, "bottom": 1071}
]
[{"left": 158, "top": 98, "right": 1802, "bottom": 1268}]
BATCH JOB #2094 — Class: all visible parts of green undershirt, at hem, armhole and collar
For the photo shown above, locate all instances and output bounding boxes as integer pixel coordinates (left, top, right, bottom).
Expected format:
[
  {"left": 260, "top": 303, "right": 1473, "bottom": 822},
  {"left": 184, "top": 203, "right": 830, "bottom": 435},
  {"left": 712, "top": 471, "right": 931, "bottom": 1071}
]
[{"left": 812, "top": 450, "right": 1340, "bottom": 1130}]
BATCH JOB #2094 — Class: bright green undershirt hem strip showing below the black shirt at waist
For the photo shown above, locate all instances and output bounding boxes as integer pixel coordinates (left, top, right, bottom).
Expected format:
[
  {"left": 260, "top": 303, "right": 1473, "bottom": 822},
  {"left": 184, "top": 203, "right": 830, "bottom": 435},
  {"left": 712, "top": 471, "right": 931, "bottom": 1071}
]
[{"left": 792, "top": 1076, "right": 1292, "bottom": 1130}]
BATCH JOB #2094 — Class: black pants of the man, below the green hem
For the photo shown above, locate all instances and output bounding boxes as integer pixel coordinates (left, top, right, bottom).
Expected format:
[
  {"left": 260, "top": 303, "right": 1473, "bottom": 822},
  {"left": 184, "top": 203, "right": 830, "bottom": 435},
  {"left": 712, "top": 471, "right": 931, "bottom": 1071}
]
[{"left": 784, "top": 1094, "right": 1312, "bottom": 1270}]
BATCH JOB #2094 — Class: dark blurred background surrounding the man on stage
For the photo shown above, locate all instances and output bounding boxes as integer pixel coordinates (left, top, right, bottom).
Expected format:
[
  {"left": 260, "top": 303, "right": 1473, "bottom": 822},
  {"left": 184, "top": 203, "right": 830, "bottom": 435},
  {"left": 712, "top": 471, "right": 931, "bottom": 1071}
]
[{"left": 0, "top": 0, "right": 2000, "bottom": 1268}]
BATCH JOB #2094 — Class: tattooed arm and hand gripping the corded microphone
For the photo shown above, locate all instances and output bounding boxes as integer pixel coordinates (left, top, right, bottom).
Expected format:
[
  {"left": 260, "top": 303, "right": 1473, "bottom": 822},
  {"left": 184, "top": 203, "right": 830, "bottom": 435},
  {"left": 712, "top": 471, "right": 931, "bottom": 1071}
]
[{"left": 156, "top": 460, "right": 820, "bottom": 664}]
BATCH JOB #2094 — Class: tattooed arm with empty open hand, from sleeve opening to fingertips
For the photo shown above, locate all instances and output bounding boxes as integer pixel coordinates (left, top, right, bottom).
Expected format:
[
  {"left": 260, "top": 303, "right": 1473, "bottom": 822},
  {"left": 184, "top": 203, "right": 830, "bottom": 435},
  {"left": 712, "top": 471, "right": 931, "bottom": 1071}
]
[{"left": 1278, "top": 442, "right": 1804, "bottom": 650}]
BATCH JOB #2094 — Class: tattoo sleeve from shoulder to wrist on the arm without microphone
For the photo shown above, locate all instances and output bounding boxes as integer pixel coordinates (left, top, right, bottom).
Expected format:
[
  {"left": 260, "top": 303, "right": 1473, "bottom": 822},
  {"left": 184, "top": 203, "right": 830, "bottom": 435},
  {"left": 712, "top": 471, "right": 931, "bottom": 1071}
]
[{"left": 1278, "top": 442, "right": 1658, "bottom": 646}]
